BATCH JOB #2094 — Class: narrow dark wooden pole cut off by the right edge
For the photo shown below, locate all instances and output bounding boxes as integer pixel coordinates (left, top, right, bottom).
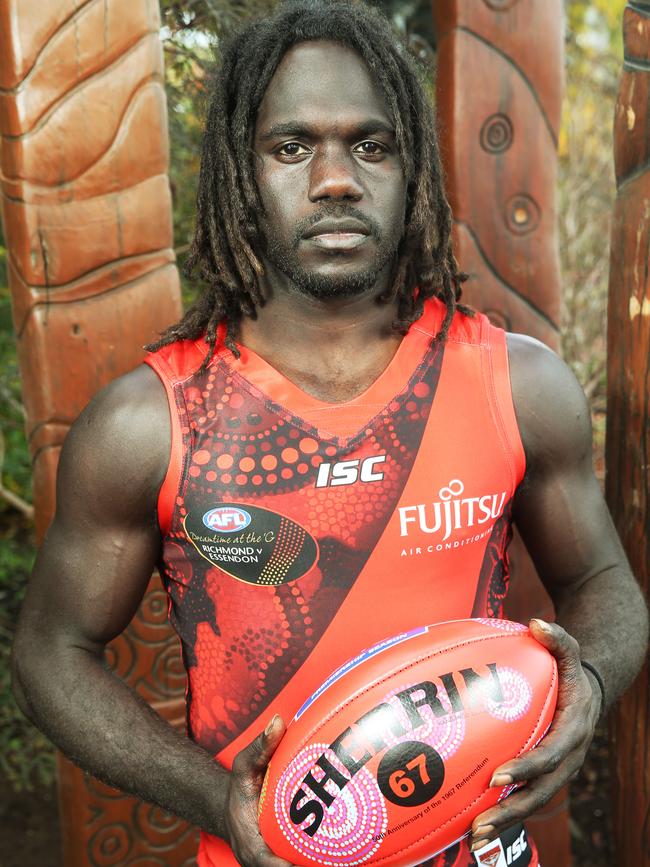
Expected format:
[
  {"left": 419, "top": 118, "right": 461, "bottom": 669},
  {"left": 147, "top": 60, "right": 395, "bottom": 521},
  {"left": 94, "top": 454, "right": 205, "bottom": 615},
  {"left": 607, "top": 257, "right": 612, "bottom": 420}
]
[{"left": 606, "top": 0, "right": 650, "bottom": 867}]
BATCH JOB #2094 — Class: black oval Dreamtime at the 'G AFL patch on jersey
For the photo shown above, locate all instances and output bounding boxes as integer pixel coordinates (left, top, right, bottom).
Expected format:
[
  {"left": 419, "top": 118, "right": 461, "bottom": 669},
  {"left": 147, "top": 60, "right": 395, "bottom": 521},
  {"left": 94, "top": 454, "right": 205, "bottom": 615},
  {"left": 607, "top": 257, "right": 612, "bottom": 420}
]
[{"left": 183, "top": 503, "right": 318, "bottom": 587}]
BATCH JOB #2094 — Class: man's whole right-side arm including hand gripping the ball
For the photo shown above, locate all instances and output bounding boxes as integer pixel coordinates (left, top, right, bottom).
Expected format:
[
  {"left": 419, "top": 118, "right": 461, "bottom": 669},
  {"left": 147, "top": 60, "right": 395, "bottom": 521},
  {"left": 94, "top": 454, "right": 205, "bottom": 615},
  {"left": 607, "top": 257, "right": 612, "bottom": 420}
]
[{"left": 473, "top": 335, "right": 648, "bottom": 848}]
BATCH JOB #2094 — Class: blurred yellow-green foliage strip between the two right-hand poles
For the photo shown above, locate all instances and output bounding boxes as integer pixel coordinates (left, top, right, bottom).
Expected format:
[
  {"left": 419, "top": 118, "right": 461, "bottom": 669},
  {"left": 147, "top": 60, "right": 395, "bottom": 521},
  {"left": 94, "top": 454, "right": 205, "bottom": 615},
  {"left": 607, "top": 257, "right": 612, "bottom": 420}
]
[{"left": 558, "top": 0, "right": 625, "bottom": 420}]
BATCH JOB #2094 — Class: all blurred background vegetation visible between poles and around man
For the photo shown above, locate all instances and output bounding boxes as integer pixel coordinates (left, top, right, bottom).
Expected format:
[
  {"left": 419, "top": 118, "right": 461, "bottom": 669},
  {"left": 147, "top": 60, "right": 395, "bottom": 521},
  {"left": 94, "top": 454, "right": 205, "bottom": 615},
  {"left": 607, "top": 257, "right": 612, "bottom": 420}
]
[{"left": 0, "top": 0, "right": 625, "bottom": 808}]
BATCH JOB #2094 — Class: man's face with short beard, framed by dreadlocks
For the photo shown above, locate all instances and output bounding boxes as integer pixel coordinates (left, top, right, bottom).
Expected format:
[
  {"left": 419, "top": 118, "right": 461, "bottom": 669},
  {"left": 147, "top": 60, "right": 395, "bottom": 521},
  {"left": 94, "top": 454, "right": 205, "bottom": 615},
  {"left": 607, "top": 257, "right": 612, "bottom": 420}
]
[{"left": 254, "top": 42, "right": 406, "bottom": 299}]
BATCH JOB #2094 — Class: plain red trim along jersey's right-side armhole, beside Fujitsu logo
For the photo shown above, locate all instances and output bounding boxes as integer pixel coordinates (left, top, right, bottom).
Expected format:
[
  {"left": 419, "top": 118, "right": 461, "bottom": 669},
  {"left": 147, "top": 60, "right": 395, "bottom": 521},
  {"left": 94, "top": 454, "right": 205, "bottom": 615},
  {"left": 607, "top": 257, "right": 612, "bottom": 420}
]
[{"left": 485, "top": 319, "right": 526, "bottom": 488}]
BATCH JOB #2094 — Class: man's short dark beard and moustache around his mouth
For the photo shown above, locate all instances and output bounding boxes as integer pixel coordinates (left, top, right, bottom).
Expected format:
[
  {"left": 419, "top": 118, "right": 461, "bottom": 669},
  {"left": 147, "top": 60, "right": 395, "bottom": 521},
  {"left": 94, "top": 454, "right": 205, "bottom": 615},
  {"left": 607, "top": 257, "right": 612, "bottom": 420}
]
[{"left": 264, "top": 205, "right": 400, "bottom": 300}]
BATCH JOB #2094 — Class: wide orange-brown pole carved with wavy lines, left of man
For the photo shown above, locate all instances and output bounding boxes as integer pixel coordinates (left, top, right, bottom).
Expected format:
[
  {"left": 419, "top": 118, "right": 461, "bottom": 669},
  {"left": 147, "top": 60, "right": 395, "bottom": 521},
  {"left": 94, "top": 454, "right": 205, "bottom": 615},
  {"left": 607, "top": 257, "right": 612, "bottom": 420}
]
[{"left": 0, "top": 0, "right": 195, "bottom": 867}]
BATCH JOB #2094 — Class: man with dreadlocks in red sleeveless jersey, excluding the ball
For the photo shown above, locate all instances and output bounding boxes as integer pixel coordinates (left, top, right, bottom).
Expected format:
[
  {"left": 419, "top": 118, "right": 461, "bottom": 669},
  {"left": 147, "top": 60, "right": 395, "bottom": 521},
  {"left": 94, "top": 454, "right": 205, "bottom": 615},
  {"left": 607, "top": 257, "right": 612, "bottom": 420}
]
[{"left": 10, "top": 2, "right": 647, "bottom": 867}]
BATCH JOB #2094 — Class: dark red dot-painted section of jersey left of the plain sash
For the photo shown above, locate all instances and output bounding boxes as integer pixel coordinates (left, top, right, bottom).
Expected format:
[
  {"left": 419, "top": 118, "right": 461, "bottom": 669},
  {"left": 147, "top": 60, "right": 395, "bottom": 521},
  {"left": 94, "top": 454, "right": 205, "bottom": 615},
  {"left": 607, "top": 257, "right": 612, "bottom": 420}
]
[{"left": 163, "top": 344, "right": 444, "bottom": 753}]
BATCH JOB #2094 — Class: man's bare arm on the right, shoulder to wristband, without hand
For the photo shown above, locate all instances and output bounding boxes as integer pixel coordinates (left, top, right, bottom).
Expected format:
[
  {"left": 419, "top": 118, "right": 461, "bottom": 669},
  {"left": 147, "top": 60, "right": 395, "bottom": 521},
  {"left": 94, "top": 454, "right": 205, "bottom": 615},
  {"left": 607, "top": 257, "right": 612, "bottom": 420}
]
[{"left": 509, "top": 335, "right": 648, "bottom": 704}]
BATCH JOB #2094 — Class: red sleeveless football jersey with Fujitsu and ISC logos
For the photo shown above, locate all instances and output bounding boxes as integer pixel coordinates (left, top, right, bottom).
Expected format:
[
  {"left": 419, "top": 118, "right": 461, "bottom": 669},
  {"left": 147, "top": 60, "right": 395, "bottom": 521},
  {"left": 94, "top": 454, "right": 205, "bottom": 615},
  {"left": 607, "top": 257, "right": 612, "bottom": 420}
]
[{"left": 146, "top": 300, "right": 537, "bottom": 867}]
